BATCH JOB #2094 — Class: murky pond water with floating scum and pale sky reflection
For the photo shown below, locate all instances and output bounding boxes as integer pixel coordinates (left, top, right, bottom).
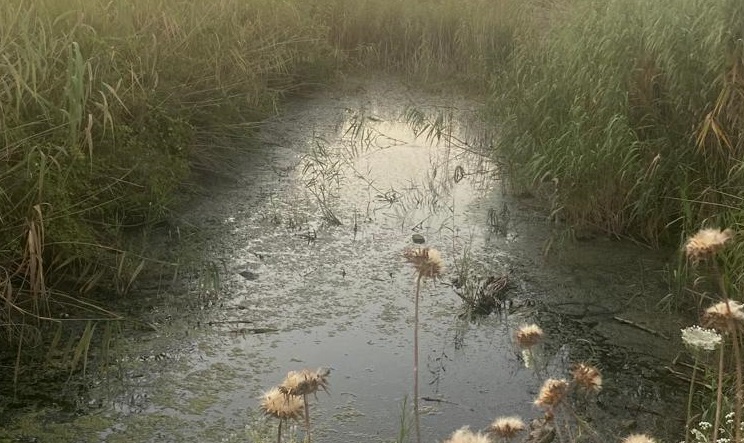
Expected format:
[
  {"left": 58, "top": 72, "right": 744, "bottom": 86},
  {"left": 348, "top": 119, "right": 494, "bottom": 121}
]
[{"left": 0, "top": 81, "right": 686, "bottom": 443}]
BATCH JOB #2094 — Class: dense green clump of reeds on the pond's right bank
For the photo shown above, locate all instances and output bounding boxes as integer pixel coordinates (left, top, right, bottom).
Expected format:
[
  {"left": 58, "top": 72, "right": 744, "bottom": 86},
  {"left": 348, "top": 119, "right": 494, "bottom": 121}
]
[{"left": 492, "top": 0, "right": 744, "bottom": 248}]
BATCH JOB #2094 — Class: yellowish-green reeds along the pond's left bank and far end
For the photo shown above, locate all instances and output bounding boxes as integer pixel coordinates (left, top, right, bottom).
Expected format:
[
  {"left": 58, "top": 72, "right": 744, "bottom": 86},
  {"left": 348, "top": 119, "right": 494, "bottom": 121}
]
[{"left": 0, "top": 0, "right": 511, "bottom": 350}]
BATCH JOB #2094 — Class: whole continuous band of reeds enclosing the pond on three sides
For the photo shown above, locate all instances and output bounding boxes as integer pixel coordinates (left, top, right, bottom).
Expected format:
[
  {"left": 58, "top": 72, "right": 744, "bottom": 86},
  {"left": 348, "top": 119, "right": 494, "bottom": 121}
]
[{"left": 0, "top": 0, "right": 744, "bottom": 438}]
